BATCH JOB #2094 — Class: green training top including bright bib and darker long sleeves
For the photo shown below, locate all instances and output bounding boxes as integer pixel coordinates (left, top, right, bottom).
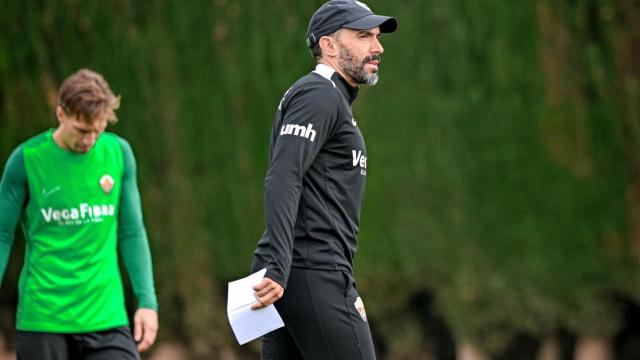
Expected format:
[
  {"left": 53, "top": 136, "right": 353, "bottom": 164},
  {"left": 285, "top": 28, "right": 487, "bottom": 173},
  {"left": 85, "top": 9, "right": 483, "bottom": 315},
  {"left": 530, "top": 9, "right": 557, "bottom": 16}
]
[{"left": 0, "top": 129, "right": 157, "bottom": 333}]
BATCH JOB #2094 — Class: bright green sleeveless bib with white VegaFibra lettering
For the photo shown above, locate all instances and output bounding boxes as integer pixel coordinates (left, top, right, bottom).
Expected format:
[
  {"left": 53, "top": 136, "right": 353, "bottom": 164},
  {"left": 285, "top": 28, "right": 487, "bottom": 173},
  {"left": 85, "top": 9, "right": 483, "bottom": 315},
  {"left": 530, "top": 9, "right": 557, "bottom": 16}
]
[{"left": 17, "top": 130, "right": 128, "bottom": 333}]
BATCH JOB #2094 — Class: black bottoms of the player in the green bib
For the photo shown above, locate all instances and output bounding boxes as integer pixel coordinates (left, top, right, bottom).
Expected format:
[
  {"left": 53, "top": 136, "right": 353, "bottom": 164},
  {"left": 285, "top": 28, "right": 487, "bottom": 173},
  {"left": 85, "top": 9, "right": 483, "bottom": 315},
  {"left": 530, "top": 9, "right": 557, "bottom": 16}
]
[{"left": 16, "top": 326, "right": 140, "bottom": 360}]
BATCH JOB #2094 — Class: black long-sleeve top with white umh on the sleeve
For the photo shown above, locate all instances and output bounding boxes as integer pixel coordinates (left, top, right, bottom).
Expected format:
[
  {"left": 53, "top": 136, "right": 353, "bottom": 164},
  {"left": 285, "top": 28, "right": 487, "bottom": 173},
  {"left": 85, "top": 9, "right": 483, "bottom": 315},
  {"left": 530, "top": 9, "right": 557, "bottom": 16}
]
[{"left": 254, "top": 64, "right": 367, "bottom": 287}]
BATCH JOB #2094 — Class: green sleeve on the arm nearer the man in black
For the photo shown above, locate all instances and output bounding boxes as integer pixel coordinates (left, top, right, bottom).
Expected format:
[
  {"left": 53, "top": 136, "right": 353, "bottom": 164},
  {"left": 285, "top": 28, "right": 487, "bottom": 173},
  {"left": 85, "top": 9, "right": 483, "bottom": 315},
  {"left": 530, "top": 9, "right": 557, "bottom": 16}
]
[{"left": 118, "top": 139, "right": 158, "bottom": 310}]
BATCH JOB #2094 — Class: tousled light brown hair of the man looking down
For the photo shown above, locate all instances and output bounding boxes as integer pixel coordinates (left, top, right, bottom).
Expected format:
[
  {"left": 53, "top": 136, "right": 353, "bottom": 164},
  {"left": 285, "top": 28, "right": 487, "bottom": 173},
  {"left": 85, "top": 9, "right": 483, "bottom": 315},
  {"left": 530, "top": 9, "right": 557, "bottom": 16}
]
[{"left": 58, "top": 69, "right": 120, "bottom": 124}]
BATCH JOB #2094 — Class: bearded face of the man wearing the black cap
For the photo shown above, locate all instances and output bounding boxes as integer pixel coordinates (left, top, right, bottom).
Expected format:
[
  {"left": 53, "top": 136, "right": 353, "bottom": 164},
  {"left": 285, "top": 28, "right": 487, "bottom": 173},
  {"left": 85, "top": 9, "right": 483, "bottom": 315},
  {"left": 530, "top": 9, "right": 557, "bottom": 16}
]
[{"left": 336, "top": 28, "right": 384, "bottom": 86}]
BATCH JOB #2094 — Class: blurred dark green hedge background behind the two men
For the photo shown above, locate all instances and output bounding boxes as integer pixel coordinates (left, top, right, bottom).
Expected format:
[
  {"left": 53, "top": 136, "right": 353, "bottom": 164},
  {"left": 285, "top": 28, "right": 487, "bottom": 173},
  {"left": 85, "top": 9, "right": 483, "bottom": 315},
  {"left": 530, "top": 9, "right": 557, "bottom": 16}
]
[{"left": 0, "top": 0, "right": 640, "bottom": 360}]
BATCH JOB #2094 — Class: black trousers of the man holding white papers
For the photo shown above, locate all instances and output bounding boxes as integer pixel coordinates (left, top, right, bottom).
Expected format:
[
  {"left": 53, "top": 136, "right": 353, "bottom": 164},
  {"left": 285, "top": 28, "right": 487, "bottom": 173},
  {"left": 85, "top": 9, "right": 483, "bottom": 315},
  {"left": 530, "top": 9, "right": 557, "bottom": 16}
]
[{"left": 262, "top": 268, "right": 376, "bottom": 360}]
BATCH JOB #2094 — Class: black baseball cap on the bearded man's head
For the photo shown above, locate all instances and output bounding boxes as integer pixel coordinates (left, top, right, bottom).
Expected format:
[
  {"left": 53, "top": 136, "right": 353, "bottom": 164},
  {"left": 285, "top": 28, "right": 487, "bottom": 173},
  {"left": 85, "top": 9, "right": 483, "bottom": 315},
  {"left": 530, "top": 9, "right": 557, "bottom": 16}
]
[{"left": 307, "top": 0, "right": 398, "bottom": 48}]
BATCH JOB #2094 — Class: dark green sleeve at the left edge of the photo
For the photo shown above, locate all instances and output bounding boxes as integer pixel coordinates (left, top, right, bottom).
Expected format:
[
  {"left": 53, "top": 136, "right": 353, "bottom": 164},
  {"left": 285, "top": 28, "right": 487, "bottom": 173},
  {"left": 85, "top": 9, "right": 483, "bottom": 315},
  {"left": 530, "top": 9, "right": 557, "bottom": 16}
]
[{"left": 0, "top": 147, "right": 28, "bottom": 284}]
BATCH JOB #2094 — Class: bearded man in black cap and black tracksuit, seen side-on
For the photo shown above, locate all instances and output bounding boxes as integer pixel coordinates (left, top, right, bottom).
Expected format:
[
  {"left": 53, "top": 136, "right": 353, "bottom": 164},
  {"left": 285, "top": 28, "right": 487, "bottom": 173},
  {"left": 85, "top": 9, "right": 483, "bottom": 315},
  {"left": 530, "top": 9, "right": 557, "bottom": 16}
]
[{"left": 252, "top": 0, "right": 397, "bottom": 360}]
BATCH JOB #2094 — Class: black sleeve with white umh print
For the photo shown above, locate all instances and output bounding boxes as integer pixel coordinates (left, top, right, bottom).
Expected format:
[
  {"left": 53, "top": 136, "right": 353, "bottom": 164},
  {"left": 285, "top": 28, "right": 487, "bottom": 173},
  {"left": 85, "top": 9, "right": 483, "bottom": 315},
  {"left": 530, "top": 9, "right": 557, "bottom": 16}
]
[{"left": 264, "top": 85, "right": 339, "bottom": 287}]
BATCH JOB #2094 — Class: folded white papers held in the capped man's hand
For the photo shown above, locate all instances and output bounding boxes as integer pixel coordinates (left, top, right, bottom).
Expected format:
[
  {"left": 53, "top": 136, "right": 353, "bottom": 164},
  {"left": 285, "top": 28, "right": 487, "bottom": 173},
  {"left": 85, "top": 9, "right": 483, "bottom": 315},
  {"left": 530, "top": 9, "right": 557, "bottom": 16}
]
[{"left": 227, "top": 269, "right": 284, "bottom": 345}]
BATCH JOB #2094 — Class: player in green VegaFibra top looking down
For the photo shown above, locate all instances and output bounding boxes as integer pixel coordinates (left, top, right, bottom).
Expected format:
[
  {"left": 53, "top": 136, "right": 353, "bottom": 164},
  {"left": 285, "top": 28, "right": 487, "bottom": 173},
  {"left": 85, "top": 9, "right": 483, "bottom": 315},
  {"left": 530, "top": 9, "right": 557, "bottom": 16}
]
[{"left": 0, "top": 69, "right": 158, "bottom": 360}]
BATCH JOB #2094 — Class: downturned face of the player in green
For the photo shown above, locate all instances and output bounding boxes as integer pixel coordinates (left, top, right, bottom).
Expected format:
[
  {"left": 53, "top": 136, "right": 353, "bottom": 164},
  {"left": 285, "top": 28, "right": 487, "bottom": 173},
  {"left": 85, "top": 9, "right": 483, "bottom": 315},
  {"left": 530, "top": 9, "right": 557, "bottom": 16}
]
[{"left": 53, "top": 107, "right": 107, "bottom": 153}]
